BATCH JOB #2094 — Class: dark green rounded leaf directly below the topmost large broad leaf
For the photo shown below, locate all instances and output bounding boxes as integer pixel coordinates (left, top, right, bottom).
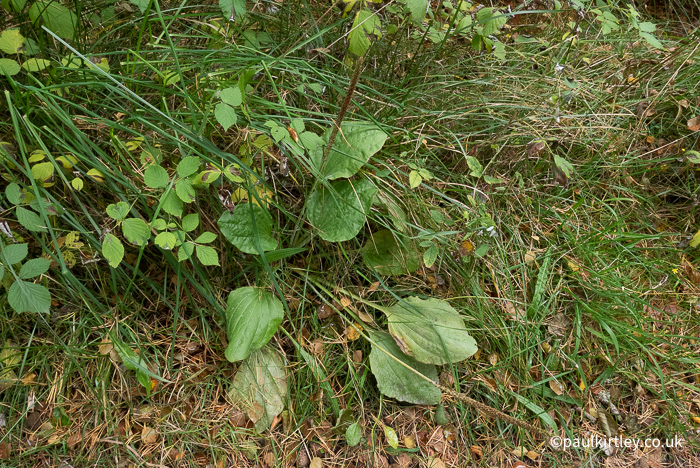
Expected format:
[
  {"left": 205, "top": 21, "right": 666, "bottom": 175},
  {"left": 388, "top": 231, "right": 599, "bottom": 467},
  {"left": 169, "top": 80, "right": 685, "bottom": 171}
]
[{"left": 306, "top": 179, "right": 377, "bottom": 242}]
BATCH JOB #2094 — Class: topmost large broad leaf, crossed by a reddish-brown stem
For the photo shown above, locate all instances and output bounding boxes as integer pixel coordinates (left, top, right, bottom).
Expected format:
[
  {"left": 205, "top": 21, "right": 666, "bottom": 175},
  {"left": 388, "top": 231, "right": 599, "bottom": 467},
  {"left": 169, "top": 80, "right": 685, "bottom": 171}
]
[{"left": 310, "top": 122, "right": 387, "bottom": 180}]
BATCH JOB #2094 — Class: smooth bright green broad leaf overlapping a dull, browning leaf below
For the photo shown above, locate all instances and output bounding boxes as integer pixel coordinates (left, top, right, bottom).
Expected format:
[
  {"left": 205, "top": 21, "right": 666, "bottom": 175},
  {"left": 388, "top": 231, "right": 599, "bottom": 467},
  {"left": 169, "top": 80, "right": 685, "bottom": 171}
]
[{"left": 225, "top": 287, "right": 284, "bottom": 362}]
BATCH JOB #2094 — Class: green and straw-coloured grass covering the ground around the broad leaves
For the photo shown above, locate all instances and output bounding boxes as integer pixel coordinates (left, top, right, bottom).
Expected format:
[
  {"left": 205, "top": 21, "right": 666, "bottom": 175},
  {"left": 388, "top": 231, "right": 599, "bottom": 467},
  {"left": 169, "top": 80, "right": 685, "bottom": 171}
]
[{"left": 0, "top": 3, "right": 700, "bottom": 467}]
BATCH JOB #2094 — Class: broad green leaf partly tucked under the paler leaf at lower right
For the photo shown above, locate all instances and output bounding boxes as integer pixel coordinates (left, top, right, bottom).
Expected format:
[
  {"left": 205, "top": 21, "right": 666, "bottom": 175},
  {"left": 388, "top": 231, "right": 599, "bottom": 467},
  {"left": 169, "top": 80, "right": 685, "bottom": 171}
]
[{"left": 369, "top": 332, "right": 442, "bottom": 405}]
